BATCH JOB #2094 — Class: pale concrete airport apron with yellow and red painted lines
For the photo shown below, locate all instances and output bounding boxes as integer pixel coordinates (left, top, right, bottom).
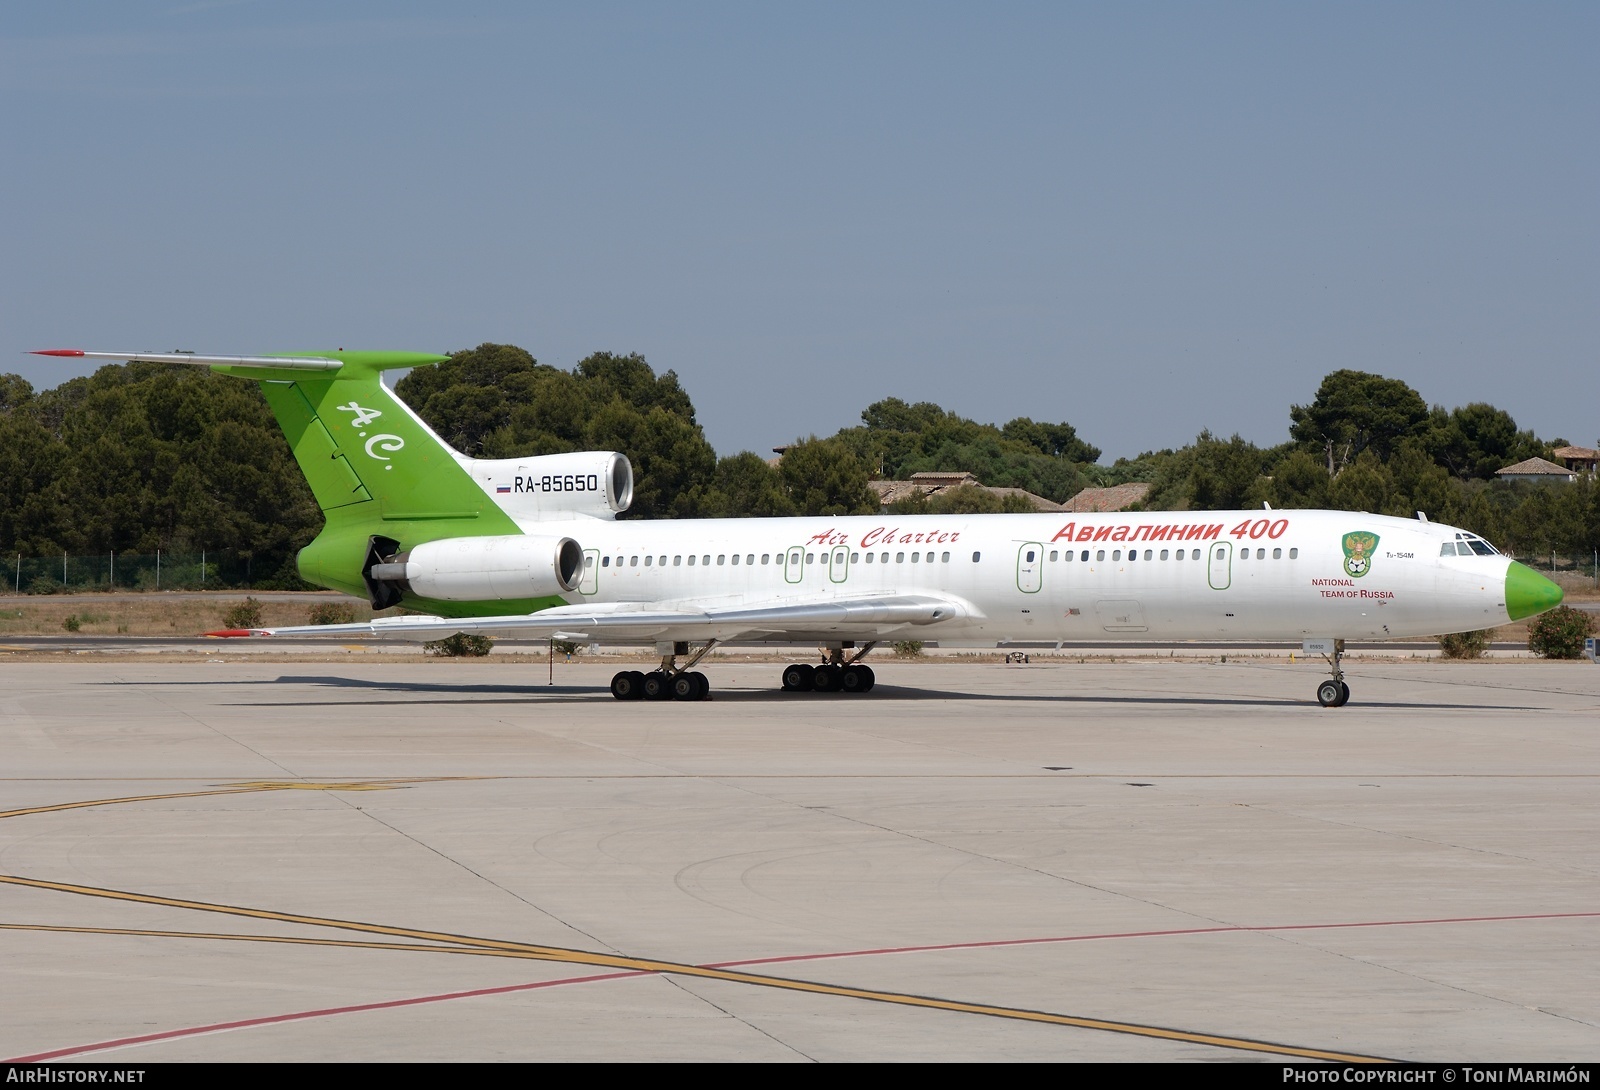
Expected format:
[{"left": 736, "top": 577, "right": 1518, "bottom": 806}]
[{"left": 0, "top": 656, "right": 1600, "bottom": 1064}]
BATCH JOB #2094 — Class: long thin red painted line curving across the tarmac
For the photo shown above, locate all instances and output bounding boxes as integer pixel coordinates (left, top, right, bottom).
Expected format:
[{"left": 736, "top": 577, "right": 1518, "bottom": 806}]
[{"left": 15, "top": 912, "right": 1600, "bottom": 1063}]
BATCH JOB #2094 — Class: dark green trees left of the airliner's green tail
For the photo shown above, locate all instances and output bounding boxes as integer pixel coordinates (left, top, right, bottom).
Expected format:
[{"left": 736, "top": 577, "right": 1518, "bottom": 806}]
[{"left": 0, "top": 363, "right": 322, "bottom": 578}]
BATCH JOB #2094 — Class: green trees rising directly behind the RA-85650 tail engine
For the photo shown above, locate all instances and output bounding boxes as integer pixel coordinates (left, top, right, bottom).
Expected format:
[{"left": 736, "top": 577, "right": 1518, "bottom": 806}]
[{"left": 395, "top": 344, "right": 717, "bottom": 519}]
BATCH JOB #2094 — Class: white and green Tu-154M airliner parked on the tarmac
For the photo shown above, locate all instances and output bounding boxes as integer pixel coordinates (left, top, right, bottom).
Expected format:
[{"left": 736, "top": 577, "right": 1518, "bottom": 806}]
[{"left": 38, "top": 349, "right": 1562, "bottom": 707}]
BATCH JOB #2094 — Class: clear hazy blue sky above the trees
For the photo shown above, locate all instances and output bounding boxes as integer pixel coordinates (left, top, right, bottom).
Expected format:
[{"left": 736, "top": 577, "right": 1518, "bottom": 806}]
[{"left": 0, "top": 2, "right": 1600, "bottom": 461}]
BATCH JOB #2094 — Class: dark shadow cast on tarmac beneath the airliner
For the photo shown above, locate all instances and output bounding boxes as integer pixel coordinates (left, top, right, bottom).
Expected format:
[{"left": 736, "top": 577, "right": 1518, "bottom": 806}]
[{"left": 117, "top": 674, "right": 1516, "bottom": 712}]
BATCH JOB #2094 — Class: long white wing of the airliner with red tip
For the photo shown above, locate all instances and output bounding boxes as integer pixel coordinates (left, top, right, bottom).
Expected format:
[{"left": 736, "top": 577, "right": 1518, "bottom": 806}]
[{"left": 208, "top": 594, "right": 971, "bottom": 643}]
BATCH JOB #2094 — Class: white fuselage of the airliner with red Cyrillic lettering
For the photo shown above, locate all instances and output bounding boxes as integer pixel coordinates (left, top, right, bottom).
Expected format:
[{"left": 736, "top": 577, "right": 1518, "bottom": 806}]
[{"left": 525, "top": 511, "right": 1510, "bottom": 645}]
